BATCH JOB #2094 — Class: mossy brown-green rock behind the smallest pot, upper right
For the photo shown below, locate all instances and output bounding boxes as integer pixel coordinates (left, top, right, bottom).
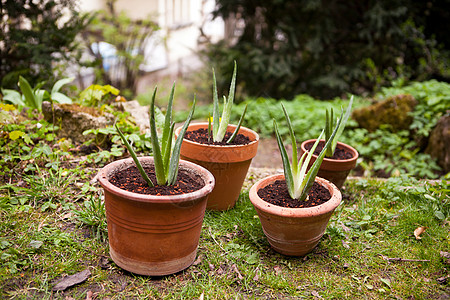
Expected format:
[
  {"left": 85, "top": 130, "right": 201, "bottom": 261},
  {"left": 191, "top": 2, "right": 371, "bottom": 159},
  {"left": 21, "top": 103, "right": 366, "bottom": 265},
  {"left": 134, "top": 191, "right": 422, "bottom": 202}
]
[{"left": 352, "top": 95, "right": 417, "bottom": 131}]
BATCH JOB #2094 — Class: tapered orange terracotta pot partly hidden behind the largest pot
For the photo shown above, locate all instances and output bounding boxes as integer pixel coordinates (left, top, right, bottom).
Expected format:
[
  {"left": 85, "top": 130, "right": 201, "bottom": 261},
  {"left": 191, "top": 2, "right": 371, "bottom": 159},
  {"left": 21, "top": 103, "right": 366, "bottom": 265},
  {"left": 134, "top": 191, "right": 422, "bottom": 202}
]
[{"left": 175, "top": 123, "right": 259, "bottom": 210}]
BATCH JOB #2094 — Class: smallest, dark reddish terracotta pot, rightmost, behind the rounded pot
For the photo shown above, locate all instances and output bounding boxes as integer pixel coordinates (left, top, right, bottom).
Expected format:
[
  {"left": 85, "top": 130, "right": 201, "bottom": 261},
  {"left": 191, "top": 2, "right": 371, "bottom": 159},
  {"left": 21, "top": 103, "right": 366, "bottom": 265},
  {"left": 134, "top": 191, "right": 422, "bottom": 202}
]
[{"left": 300, "top": 139, "right": 359, "bottom": 189}]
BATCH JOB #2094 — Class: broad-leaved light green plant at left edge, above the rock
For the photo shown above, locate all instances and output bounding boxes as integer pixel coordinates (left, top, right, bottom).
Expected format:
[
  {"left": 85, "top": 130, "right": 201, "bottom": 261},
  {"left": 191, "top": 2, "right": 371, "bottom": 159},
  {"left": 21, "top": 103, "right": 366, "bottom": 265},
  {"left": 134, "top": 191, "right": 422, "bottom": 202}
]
[{"left": 2, "top": 76, "right": 73, "bottom": 111}]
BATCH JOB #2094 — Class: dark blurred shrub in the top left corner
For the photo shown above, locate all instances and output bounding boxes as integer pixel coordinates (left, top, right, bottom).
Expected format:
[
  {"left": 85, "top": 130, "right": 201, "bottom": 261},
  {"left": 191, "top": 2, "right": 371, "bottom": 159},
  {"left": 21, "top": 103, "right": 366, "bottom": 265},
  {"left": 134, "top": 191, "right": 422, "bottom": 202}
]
[{"left": 0, "top": 0, "right": 90, "bottom": 88}]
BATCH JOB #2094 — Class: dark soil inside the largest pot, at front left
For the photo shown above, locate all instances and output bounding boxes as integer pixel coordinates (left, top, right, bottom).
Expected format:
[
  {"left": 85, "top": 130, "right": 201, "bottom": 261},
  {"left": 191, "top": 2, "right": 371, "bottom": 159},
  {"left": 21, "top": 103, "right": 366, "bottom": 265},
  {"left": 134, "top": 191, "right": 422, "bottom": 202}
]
[{"left": 109, "top": 165, "right": 205, "bottom": 196}]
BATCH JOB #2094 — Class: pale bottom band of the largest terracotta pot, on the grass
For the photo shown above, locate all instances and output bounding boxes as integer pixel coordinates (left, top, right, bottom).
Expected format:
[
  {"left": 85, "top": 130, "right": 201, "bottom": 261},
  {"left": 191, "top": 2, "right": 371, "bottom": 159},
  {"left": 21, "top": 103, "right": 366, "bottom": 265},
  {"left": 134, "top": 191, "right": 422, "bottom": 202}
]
[{"left": 109, "top": 247, "right": 197, "bottom": 276}]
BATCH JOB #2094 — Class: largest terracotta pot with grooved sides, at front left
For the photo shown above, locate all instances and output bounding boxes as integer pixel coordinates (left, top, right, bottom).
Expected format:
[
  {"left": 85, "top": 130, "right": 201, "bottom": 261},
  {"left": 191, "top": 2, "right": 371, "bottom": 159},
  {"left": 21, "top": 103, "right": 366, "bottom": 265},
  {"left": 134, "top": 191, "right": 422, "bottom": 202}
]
[{"left": 98, "top": 157, "right": 214, "bottom": 276}]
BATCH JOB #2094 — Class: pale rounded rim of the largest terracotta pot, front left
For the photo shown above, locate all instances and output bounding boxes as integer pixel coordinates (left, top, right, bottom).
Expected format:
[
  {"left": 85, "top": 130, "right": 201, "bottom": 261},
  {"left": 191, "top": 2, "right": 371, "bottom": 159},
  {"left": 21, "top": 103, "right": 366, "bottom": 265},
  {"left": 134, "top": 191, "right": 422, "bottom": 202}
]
[{"left": 97, "top": 156, "right": 215, "bottom": 203}]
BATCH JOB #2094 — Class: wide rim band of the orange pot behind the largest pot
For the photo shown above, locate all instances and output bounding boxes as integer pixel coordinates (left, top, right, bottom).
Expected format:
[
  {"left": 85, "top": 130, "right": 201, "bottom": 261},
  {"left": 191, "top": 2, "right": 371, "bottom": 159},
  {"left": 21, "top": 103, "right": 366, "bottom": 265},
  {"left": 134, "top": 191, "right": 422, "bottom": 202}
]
[{"left": 175, "top": 122, "right": 259, "bottom": 162}]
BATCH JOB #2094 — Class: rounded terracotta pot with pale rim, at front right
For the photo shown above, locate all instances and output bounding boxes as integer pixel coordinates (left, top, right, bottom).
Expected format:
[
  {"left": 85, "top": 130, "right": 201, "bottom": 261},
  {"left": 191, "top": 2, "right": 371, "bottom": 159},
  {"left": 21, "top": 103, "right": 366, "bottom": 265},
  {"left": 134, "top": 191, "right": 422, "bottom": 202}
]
[{"left": 249, "top": 174, "right": 342, "bottom": 256}]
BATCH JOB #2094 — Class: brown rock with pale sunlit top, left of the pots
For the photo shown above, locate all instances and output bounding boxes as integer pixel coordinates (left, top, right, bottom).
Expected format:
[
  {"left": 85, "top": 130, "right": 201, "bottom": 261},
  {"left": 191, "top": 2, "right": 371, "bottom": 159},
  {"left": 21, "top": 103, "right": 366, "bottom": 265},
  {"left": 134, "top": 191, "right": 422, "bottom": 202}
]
[{"left": 42, "top": 101, "right": 114, "bottom": 143}]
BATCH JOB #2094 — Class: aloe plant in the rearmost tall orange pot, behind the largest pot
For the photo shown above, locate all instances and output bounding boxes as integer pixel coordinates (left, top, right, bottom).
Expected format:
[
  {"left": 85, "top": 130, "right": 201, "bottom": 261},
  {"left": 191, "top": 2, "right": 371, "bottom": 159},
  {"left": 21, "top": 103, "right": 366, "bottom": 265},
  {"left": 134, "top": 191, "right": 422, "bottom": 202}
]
[{"left": 208, "top": 62, "right": 247, "bottom": 144}]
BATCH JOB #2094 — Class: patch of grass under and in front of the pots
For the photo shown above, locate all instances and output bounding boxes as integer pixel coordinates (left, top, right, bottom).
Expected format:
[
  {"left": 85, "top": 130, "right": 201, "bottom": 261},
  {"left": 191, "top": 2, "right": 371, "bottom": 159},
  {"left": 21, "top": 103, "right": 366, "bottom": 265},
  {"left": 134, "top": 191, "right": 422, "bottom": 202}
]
[{"left": 0, "top": 177, "right": 450, "bottom": 299}]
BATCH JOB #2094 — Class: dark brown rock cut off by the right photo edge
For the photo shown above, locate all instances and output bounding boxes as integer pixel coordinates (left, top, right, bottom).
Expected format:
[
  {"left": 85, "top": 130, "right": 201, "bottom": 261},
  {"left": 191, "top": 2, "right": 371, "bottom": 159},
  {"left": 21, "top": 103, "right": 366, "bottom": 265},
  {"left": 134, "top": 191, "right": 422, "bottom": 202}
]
[{"left": 425, "top": 111, "right": 450, "bottom": 173}]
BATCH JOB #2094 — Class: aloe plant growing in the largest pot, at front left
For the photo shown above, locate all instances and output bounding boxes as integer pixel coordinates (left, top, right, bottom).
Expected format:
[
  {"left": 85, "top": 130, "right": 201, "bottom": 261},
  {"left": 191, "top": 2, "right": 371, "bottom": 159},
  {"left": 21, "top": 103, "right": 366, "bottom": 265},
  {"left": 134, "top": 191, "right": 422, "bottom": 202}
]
[{"left": 115, "top": 84, "right": 195, "bottom": 186}]
